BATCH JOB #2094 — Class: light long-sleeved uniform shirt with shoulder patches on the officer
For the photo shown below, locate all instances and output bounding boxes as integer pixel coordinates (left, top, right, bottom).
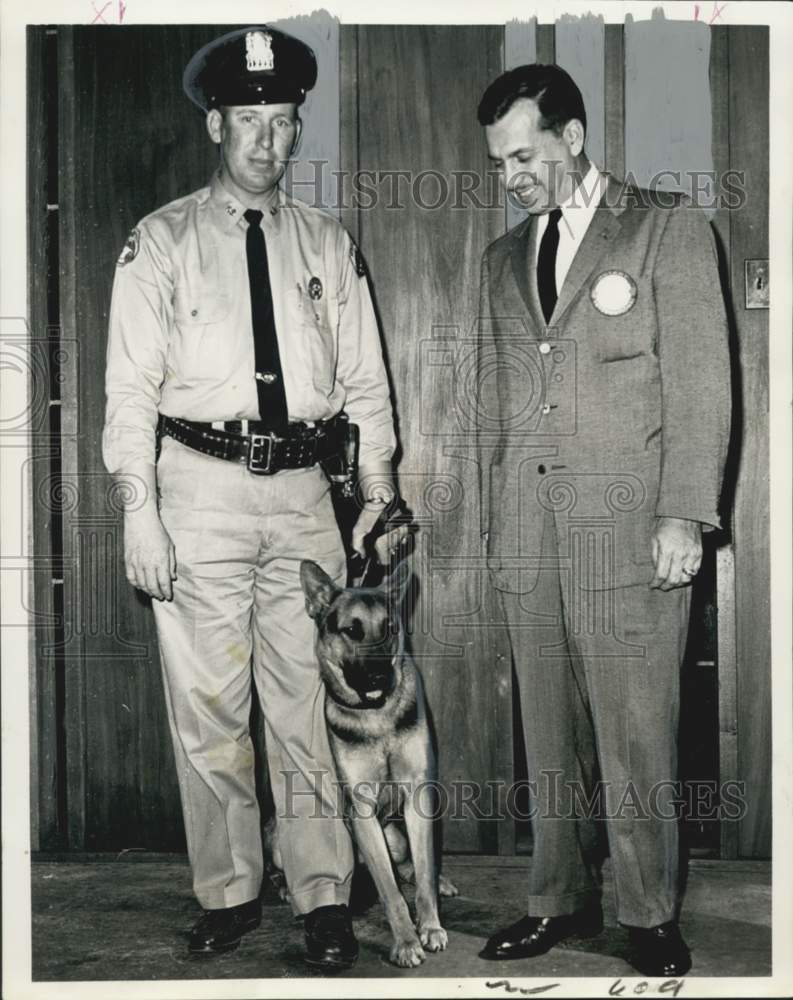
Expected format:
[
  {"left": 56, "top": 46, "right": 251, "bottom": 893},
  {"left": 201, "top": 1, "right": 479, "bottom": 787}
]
[{"left": 102, "top": 175, "right": 396, "bottom": 473}]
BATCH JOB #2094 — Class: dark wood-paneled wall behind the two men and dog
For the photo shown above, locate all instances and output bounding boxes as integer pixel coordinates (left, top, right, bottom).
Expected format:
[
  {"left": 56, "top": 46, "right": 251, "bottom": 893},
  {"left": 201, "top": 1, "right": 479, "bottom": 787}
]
[{"left": 29, "top": 19, "right": 770, "bottom": 856}]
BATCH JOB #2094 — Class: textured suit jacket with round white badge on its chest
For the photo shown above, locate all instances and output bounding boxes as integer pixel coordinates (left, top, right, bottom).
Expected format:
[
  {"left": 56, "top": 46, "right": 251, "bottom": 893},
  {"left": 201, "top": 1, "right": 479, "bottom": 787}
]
[{"left": 475, "top": 177, "right": 730, "bottom": 593}]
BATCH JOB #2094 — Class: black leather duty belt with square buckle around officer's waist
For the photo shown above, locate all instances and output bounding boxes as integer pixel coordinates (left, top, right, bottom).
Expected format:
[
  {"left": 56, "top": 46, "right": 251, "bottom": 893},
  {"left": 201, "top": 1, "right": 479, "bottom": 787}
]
[{"left": 159, "top": 415, "right": 346, "bottom": 476}]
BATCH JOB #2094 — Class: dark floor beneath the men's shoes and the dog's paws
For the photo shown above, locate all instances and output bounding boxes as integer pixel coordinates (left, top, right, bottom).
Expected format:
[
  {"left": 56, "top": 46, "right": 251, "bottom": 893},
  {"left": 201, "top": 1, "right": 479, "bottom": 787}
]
[{"left": 32, "top": 856, "right": 771, "bottom": 985}]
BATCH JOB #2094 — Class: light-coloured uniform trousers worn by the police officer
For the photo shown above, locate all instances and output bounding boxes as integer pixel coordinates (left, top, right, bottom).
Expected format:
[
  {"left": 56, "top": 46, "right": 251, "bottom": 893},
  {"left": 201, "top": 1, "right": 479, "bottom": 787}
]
[{"left": 154, "top": 437, "right": 353, "bottom": 913}]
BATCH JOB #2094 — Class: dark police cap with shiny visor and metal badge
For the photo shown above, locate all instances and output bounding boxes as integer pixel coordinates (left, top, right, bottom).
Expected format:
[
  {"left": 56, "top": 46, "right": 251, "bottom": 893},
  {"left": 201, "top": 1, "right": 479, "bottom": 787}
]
[{"left": 182, "top": 25, "right": 317, "bottom": 111}]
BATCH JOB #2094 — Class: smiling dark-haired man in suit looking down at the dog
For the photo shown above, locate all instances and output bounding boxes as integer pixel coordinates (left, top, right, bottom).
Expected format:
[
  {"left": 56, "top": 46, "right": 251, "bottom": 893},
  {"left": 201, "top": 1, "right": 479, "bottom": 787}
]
[{"left": 477, "top": 65, "right": 730, "bottom": 976}]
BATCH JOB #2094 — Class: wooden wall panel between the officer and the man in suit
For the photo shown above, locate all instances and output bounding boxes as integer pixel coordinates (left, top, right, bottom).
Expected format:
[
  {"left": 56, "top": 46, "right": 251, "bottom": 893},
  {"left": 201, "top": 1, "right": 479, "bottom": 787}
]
[{"left": 350, "top": 26, "right": 512, "bottom": 852}]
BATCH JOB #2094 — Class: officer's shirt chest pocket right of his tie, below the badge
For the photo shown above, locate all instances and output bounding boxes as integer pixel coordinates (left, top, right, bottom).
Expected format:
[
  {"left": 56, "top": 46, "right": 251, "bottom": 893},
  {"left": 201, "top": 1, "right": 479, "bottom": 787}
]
[{"left": 279, "top": 287, "right": 338, "bottom": 393}]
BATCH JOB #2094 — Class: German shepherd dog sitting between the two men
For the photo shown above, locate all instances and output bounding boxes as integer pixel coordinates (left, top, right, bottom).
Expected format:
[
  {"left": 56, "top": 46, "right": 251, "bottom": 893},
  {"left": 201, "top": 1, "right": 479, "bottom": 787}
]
[{"left": 290, "top": 560, "right": 457, "bottom": 967}]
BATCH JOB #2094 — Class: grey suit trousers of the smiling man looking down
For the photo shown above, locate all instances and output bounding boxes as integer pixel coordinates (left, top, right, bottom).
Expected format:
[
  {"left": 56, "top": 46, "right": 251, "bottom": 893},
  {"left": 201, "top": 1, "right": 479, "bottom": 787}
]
[{"left": 501, "top": 513, "right": 690, "bottom": 927}]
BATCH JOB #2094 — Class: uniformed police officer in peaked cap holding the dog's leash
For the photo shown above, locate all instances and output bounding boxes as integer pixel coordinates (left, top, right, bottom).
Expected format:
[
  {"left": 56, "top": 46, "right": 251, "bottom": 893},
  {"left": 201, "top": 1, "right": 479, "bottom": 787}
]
[{"left": 103, "top": 26, "right": 395, "bottom": 968}]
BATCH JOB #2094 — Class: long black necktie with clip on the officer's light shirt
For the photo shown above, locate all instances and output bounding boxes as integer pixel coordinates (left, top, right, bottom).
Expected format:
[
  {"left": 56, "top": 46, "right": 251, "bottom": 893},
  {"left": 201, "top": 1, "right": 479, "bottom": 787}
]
[{"left": 245, "top": 208, "right": 287, "bottom": 430}]
